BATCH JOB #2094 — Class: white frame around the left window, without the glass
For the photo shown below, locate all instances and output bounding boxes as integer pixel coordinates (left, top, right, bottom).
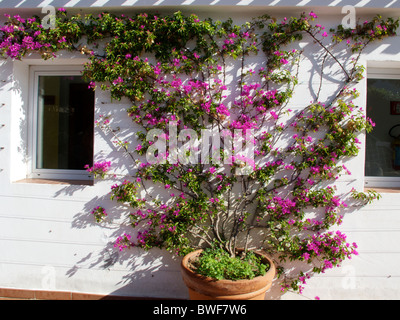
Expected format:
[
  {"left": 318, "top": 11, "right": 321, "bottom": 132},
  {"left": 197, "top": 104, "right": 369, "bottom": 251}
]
[{"left": 28, "top": 65, "right": 94, "bottom": 180}]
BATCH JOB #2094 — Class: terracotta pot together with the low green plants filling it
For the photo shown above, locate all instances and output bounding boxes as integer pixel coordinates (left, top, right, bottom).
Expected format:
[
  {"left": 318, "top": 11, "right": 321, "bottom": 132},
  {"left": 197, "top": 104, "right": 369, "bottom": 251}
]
[{"left": 181, "top": 247, "right": 276, "bottom": 300}]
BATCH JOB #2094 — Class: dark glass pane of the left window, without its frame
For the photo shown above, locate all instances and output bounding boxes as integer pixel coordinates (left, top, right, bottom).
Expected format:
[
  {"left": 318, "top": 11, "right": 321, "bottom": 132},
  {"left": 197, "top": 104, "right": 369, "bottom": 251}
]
[{"left": 37, "top": 76, "right": 94, "bottom": 170}]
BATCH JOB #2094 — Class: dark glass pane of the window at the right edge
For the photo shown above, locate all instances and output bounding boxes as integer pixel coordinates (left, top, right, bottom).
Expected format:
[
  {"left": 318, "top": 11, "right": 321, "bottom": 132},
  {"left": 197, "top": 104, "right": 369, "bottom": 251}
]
[{"left": 365, "top": 79, "right": 400, "bottom": 177}]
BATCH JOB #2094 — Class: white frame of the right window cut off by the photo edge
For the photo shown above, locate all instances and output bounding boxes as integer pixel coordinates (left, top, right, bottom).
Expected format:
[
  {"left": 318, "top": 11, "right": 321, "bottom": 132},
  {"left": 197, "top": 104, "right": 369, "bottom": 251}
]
[{"left": 364, "top": 64, "right": 400, "bottom": 188}]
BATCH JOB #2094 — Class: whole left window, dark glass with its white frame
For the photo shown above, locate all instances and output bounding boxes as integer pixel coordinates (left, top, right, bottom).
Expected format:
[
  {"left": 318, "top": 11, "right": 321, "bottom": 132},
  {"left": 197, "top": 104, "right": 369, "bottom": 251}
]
[{"left": 30, "top": 66, "right": 94, "bottom": 179}]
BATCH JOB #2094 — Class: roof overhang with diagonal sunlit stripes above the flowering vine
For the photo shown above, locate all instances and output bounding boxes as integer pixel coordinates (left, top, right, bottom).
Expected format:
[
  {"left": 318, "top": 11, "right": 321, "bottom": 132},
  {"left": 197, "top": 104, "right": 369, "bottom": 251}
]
[{"left": 0, "top": 0, "right": 400, "bottom": 18}]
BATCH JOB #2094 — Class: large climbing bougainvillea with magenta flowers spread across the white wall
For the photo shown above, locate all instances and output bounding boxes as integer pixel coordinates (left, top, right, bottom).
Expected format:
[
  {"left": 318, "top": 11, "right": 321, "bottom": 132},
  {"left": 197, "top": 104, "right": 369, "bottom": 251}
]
[{"left": 0, "top": 9, "right": 399, "bottom": 292}]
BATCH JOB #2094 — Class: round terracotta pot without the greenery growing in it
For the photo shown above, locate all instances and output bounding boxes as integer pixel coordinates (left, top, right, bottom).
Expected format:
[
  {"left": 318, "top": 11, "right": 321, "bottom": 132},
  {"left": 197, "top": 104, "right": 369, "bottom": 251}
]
[{"left": 181, "top": 250, "right": 276, "bottom": 300}]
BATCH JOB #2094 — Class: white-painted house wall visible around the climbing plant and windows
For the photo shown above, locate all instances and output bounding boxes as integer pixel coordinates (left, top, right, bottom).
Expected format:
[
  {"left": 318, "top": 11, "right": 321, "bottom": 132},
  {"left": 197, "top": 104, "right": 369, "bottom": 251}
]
[{"left": 0, "top": 0, "right": 400, "bottom": 299}]
